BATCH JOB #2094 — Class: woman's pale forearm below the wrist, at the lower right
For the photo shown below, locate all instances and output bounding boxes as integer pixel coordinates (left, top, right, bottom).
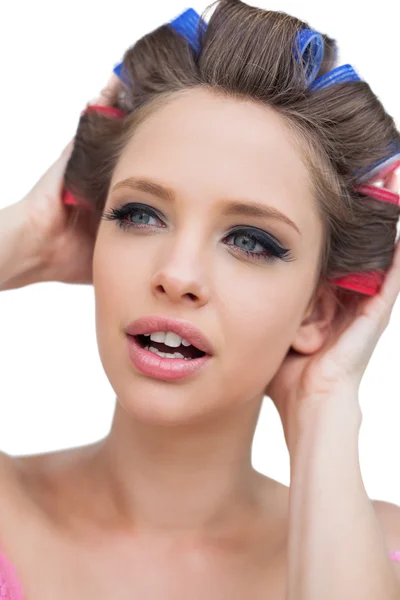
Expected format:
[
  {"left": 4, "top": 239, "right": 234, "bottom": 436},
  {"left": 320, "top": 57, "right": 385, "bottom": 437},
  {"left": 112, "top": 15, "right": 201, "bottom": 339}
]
[{"left": 288, "top": 393, "right": 400, "bottom": 600}]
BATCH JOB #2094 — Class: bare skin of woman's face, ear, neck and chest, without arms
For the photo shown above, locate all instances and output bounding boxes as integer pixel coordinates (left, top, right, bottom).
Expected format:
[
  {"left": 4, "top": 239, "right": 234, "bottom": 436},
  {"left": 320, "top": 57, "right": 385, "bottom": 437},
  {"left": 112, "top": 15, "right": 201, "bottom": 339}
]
[{"left": 0, "top": 90, "right": 396, "bottom": 600}]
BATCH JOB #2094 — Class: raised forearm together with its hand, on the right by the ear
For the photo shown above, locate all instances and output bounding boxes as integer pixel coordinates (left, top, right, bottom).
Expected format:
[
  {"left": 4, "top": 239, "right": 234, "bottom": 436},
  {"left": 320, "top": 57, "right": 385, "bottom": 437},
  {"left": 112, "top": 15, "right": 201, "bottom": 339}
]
[{"left": 267, "top": 220, "right": 400, "bottom": 600}]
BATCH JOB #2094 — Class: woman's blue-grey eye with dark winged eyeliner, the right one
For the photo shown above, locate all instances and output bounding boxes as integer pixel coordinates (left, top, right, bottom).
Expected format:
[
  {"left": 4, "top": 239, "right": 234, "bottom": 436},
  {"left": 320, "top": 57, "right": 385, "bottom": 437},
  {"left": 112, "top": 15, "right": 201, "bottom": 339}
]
[{"left": 224, "top": 227, "right": 293, "bottom": 262}]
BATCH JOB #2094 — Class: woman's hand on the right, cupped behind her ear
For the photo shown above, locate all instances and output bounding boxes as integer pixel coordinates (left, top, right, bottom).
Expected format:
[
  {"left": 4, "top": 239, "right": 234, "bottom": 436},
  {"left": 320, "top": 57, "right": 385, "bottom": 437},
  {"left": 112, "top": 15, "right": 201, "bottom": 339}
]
[{"left": 265, "top": 168, "right": 400, "bottom": 452}]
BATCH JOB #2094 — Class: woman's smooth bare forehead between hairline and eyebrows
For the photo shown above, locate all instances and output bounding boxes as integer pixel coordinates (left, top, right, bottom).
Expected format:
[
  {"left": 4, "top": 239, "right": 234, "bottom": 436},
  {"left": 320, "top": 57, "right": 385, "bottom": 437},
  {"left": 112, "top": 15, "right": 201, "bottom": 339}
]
[{"left": 111, "top": 88, "right": 318, "bottom": 238}]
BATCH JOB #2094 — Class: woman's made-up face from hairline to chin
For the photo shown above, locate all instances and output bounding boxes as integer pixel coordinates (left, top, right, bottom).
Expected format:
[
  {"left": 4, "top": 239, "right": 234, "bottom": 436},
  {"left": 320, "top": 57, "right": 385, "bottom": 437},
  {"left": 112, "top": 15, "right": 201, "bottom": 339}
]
[{"left": 93, "top": 89, "right": 322, "bottom": 423}]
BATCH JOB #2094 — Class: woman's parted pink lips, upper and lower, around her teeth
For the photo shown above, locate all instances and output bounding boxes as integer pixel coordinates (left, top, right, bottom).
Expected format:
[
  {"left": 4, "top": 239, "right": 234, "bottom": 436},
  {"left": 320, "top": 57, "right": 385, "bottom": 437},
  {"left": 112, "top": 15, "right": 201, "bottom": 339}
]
[{"left": 125, "top": 316, "right": 214, "bottom": 381}]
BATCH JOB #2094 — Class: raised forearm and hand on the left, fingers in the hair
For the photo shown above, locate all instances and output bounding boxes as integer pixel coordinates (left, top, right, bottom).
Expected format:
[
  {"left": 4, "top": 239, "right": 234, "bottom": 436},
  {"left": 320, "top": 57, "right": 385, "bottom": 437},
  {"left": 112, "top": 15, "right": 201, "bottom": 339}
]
[{"left": 0, "top": 73, "right": 122, "bottom": 291}]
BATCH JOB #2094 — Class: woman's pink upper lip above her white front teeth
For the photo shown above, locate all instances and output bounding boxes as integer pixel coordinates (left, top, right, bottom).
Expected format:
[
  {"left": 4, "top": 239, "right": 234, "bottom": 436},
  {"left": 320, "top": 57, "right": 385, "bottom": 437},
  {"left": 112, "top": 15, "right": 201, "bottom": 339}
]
[{"left": 125, "top": 315, "right": 214, "bottom": 362}]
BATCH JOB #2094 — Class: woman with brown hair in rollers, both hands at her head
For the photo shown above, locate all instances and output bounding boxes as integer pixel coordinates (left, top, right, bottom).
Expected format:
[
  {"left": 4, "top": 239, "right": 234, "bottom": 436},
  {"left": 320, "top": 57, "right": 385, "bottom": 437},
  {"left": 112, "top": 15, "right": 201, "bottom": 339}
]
[{"left": 0, "top": 0, "right": 400, "bottom": 600}]
